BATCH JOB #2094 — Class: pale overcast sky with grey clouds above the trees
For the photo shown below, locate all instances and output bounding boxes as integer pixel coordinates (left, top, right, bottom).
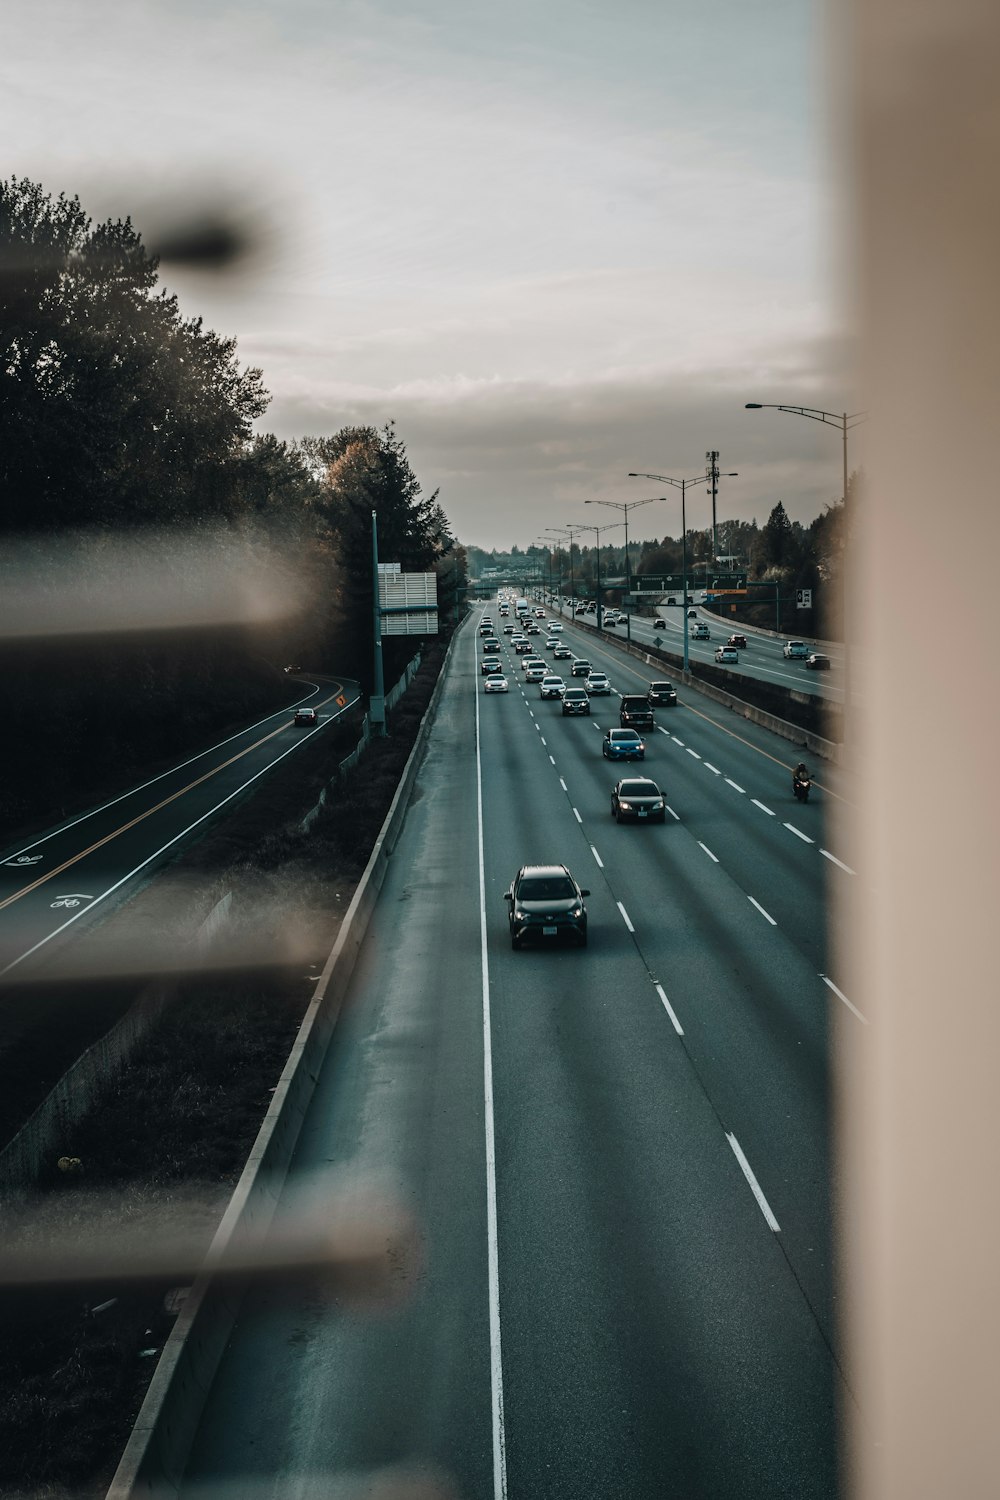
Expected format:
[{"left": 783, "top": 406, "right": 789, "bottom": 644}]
[{"left": 0, "top": 0, "right": 864, "bottom": 549}]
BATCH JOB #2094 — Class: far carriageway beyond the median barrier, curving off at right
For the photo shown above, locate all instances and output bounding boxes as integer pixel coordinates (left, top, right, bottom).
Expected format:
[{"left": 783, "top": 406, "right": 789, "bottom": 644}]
[{"left": 551, "top": 605, "right": 844, "bottom": 704}]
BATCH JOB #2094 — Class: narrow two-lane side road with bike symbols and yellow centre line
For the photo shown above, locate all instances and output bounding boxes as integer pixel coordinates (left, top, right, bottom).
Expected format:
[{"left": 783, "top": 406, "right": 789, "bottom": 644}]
[{"left": 0, "top": 678, "right": 360, "bottom": 978}]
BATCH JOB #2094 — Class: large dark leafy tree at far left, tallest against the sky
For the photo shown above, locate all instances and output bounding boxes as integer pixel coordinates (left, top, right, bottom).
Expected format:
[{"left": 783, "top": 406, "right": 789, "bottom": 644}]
[{"left": 0, "top": 177, "right": 268, "bottom": 531}]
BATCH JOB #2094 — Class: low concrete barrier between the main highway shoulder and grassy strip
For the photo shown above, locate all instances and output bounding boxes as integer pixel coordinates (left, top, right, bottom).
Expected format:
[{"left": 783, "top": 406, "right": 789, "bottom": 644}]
[{"left": 106, "top": 629, "right": 462, "bottom": 1500}]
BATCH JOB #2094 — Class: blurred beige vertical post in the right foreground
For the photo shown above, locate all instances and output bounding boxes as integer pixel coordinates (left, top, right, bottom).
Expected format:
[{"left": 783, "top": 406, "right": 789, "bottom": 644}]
[{"left": 835, "top": 0, "right": 1000, "bottom": 1500}]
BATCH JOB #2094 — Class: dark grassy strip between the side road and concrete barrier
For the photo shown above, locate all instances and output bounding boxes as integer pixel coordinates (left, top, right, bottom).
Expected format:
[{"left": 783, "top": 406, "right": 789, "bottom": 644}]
[{"left": 0, "top": 645, "right": 444, "bottom": 1500}]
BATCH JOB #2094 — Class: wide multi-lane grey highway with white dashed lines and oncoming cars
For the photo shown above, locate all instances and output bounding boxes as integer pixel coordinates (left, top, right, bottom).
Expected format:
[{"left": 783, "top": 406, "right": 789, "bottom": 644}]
[{"left": 184, "top": 605, "right": 851, "bottom": 1500}]
